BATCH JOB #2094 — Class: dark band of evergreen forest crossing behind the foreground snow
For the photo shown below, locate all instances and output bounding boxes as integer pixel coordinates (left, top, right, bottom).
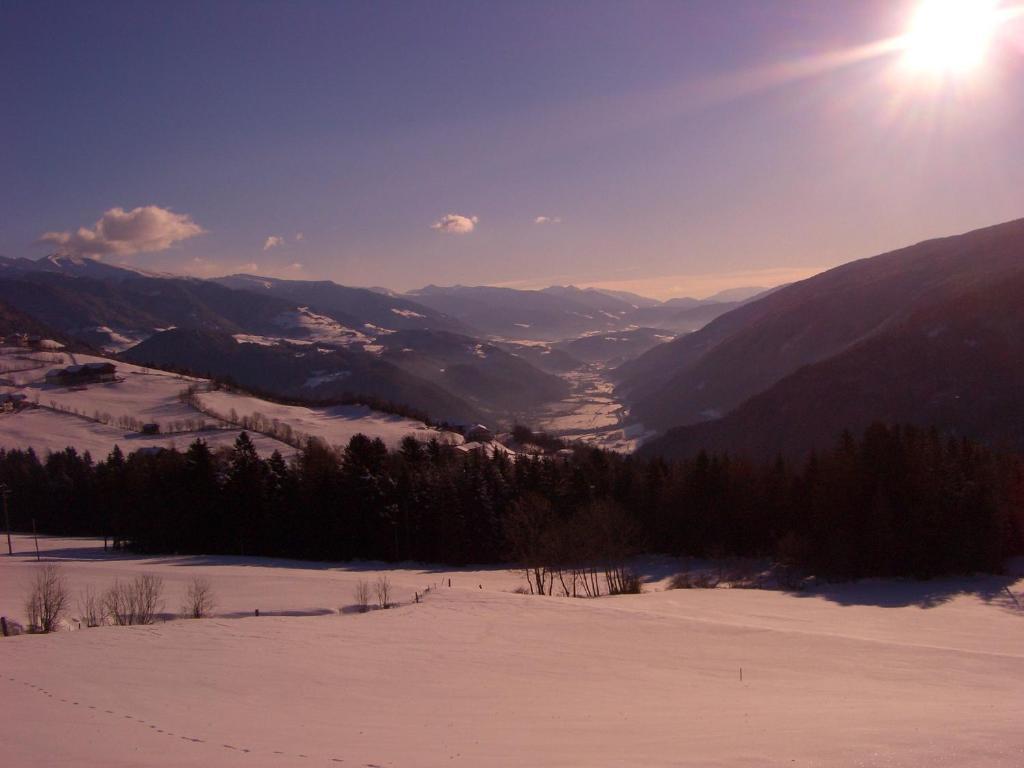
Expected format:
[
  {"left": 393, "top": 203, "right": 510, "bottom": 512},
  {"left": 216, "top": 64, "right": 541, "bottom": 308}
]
[{"left": 0, "top": 425, "right": 1024, "bottom": 581}]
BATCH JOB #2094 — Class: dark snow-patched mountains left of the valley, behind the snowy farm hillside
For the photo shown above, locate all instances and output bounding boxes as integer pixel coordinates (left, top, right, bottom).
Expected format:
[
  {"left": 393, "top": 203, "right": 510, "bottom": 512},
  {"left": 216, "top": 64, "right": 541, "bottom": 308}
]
[{"left": 0, "top": 255, "right": 704, "bottom": 422}]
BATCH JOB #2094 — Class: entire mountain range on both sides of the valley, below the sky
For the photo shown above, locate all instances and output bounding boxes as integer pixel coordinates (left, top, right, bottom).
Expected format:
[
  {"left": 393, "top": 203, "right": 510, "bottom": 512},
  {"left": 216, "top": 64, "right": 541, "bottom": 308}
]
[{"left": 9, "top": 214, "right": 1024, "bottom": 457}]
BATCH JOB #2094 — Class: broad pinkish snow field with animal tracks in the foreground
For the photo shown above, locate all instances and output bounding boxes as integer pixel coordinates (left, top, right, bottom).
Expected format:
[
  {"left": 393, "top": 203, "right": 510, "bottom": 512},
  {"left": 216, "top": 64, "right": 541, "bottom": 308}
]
[{"left": 0, "top": 537, "right": 1024, "bottom": 768}]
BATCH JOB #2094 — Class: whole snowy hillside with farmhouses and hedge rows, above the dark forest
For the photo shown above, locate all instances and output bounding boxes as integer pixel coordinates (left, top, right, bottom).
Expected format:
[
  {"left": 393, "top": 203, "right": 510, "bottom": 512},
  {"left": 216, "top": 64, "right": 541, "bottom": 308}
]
[{"left": 0, "top": 348, "right": 462, "bottom": 458}]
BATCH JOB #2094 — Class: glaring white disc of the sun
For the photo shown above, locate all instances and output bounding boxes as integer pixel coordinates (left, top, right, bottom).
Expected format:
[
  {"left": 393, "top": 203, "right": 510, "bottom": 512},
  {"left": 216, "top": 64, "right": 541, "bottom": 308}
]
[{"left": 905, "top": 0, "right": 999, "bottom": 75}]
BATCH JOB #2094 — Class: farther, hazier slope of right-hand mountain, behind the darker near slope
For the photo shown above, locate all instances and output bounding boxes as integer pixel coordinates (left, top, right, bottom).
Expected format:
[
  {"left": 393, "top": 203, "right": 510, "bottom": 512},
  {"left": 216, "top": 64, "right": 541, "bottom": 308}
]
[{"left": 615, "top": 220, "right": 1024, "bottom": 427}]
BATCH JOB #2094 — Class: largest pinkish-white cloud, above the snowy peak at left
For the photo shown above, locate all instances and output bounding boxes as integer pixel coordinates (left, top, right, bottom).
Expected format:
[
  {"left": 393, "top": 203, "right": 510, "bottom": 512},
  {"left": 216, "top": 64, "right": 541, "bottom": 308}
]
[{"left": 39, "top": 206, "right": 205, "bottom": 258}]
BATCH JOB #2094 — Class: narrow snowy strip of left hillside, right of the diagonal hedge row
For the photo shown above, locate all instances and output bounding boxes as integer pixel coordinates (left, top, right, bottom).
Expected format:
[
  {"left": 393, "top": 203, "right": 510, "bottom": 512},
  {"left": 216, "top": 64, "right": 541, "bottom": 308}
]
[{"left": 197, "top": 390, "right": 462, "bottom": 447}]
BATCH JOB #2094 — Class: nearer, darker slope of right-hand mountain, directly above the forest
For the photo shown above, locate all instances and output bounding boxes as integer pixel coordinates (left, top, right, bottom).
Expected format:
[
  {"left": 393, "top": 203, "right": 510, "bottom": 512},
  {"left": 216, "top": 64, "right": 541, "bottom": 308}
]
[{"left": 643, "top": 270, "right": 1024, "bottom": 458}]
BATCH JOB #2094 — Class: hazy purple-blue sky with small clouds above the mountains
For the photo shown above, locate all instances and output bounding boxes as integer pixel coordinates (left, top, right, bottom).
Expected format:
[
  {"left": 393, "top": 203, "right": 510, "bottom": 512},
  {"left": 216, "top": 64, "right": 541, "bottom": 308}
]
[{"left": 0, "top": 0, "right": 1024, "bottom": 297}]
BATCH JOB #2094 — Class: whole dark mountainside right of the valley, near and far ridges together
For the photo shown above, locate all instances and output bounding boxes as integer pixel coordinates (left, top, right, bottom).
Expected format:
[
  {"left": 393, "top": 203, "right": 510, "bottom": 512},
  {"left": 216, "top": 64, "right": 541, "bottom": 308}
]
[{"left": 616, "top": 219, "right": 1024, "bottom": 455}]
